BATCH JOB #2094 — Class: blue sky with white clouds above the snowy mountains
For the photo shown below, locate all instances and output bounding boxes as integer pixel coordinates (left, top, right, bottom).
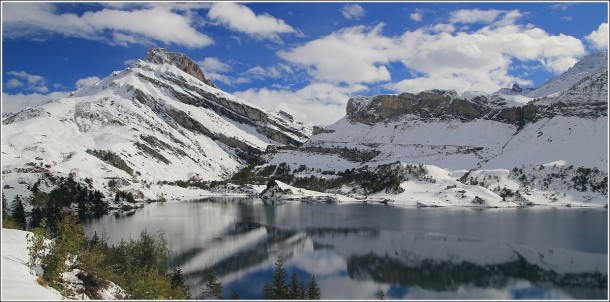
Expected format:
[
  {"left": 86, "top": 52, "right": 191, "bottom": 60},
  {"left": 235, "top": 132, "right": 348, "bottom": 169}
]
[{"left": 1, "top": 1, "right": 608, "bottom": 125}]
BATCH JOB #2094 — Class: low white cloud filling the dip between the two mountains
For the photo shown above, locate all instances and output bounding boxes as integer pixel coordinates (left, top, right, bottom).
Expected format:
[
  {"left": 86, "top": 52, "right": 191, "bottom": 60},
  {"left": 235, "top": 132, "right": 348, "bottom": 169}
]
[{"left": 234, "top": 83, "right": 367, "bottom": 125}]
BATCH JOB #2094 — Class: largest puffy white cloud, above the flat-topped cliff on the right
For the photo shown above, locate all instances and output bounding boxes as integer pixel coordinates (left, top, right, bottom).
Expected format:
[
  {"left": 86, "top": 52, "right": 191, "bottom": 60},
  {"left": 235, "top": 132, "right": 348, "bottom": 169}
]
[{"left": 386, "top": 24, "right": 585, "bottom": 92}]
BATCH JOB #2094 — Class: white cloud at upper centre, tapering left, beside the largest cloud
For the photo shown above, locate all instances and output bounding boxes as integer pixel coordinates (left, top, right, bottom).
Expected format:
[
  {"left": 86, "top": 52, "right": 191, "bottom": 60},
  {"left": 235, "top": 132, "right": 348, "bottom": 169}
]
[{"left": 278, "top": 24, "right": 395, "bottom": 84}]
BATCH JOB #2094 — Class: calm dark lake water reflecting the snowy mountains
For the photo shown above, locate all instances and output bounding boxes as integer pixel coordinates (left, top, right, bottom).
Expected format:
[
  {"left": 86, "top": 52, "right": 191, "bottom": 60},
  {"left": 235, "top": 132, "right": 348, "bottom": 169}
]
[{"left": 79, "top": 199, "right": 608, "bottom": 300}]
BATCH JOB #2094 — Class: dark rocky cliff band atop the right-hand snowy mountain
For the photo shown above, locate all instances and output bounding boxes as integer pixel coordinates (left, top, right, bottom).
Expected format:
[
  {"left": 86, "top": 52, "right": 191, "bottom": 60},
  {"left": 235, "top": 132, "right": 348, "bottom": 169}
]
[{"left": 346, "top": 69, "right": 608, "bottom": 127}]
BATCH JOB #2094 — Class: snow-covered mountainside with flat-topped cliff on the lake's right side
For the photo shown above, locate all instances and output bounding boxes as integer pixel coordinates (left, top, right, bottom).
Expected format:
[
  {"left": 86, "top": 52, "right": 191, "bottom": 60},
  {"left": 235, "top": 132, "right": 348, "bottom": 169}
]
[{"left": 269, "top": 53, "right": 608, "bottom": 206}]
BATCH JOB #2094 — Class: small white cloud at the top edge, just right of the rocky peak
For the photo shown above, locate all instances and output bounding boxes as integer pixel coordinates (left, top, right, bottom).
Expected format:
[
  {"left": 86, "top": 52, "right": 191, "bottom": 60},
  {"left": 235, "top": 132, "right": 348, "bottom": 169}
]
[{"left": 208, "top": 2, "right": 296, "bottom": 42}]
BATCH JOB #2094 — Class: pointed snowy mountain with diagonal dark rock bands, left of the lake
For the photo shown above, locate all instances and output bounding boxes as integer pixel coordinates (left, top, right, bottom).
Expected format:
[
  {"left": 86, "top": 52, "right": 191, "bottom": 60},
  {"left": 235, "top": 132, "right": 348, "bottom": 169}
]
[{"left": 2, "top": 48, "right": 311, "bottom": 201}]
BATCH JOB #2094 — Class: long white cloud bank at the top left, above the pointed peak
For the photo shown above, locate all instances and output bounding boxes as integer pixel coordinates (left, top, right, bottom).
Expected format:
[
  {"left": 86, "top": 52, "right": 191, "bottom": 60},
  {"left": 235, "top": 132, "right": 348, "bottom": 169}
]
[{"left": 2, "top": 3, "right": 213, "bottom": 48}]
